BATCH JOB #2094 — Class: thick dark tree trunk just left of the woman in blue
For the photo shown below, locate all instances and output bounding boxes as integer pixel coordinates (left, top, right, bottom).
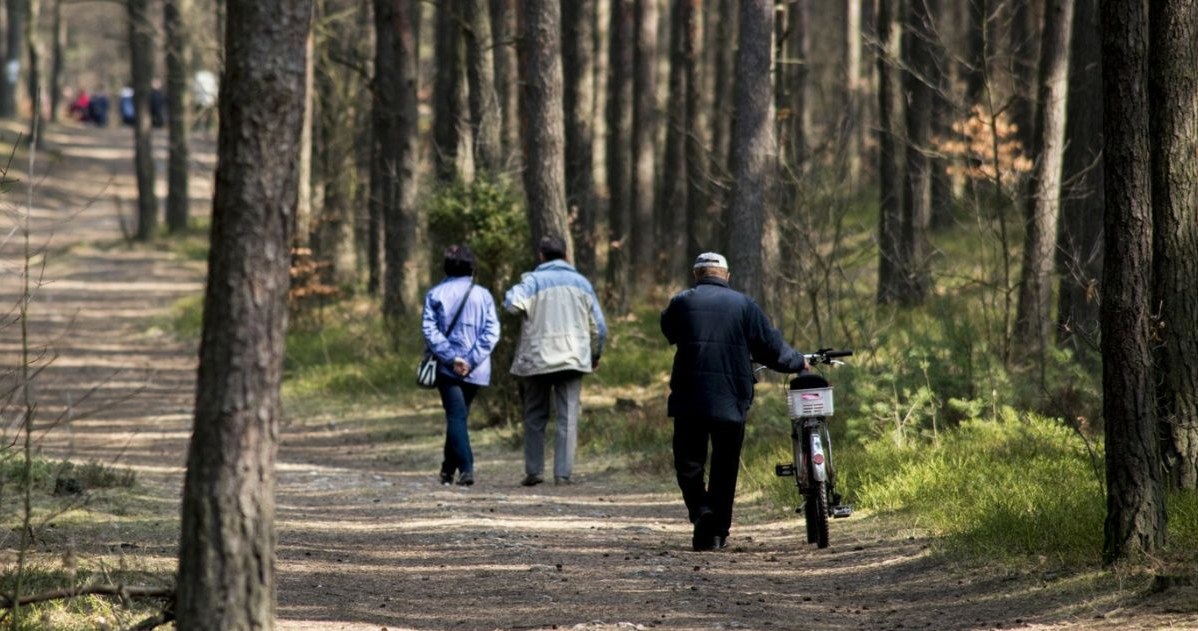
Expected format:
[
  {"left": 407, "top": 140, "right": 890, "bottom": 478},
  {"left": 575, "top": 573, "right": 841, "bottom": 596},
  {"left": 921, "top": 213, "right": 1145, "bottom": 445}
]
[{"left": 371, "top": 0, "right": 423, "bottom": 323}]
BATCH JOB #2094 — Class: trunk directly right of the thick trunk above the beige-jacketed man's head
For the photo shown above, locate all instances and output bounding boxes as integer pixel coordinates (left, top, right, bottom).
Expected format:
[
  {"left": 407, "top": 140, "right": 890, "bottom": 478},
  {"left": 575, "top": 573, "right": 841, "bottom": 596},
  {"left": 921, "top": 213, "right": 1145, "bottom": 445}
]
[{"left": 562, "top": 0, "right": 598, "bottom": 275}]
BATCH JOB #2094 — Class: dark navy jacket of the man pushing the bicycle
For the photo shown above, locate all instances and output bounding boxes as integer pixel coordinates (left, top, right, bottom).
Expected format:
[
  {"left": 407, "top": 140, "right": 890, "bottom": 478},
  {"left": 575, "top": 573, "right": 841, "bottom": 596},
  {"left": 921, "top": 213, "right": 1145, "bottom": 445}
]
[{"left": 661, "top": 277, "right": 804, "bottom": 423}]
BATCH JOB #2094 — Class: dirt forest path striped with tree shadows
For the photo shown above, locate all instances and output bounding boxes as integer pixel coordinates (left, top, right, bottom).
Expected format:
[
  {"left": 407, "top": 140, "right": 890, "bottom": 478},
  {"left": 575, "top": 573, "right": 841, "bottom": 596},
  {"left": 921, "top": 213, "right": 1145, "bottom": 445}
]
[{"left": 0, "top": 119, "right": 1198, "bottom": 631}]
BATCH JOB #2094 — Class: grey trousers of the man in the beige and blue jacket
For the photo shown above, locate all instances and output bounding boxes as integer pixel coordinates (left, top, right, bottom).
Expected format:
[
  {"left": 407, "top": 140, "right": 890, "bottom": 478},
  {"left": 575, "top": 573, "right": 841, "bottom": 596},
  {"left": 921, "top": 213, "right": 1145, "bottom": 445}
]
[{"left": 524, "top": 371, "right": 582, "bottom": 478}]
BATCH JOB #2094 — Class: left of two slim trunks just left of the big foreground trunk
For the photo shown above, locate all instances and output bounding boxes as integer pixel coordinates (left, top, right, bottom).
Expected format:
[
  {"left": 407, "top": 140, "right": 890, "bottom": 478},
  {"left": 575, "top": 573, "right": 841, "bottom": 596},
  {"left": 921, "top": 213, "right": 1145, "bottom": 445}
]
[{"left": 126, "top": 0, "right": 158, "bottom": 241}]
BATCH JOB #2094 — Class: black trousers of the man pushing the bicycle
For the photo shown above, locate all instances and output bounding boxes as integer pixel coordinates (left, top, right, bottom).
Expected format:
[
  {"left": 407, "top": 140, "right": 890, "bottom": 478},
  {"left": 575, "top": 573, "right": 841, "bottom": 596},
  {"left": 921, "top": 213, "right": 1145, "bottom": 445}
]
[{"left": 673, "top": 417, "right": 745, "bottom": 536}]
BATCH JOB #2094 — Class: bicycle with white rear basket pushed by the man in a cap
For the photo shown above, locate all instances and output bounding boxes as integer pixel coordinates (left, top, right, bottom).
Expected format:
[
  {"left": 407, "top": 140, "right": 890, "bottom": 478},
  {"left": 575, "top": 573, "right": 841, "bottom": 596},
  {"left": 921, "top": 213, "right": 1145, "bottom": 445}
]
[{"left": 774, "top": 348, "right": 853, "bottom": 548}]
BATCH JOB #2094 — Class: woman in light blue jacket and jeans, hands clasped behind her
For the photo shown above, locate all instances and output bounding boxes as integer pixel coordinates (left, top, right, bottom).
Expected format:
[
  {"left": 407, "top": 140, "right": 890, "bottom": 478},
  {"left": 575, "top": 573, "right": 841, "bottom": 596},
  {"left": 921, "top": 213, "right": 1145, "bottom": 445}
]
[{"left": 420, "top": 245, "right": 500, "bottom": 486}]
